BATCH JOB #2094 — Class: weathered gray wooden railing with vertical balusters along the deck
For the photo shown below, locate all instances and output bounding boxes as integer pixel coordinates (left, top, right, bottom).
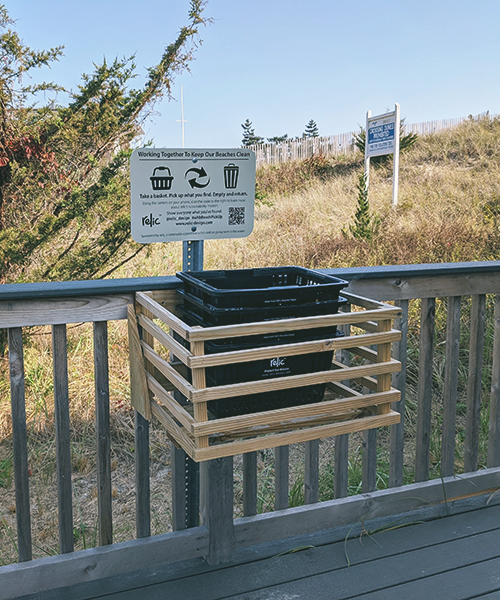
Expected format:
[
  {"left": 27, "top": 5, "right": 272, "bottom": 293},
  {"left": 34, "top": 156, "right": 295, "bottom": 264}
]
[{"left": 0, "top": 262, "right": 500, "bottom": 599}]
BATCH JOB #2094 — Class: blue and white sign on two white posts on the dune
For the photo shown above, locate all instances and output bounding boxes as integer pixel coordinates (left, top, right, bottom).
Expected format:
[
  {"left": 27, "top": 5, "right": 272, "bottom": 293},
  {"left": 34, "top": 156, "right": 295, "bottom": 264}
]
[{"left": 365, "top": 103, "right": 400, "bottom": 206}]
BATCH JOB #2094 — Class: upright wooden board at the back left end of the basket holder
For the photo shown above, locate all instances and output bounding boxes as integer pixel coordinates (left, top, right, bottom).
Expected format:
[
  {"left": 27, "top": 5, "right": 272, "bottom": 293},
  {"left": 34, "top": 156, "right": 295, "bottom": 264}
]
[{"left": 127, "top": 304, "right": 151, "bottom": 421}]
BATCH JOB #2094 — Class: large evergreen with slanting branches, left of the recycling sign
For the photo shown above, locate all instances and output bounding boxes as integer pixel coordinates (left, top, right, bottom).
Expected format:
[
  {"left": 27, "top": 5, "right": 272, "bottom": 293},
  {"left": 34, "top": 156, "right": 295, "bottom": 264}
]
[{"left": 0, "top": 0, "right": 207, "bottom": 283}]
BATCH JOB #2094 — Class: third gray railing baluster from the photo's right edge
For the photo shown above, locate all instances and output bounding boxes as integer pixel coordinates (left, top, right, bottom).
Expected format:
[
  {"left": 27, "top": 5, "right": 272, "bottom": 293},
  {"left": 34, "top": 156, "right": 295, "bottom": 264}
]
[{"left": 441, "top": 296, "right": 461, "bottom": 477}]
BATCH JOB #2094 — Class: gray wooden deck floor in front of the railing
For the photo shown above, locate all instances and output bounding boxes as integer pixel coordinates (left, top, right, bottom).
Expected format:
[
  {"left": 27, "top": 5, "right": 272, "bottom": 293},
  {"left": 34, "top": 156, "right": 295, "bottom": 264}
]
[{"left": 25, "top": 506, "right": 500, "bottom": 600}]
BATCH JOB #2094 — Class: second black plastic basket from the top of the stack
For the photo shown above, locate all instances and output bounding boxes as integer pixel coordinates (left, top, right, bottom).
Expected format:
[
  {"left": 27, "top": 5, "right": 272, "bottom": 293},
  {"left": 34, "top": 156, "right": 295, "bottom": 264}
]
[{"left": 177, "top": 290, "right": 347, "bottom": 326}]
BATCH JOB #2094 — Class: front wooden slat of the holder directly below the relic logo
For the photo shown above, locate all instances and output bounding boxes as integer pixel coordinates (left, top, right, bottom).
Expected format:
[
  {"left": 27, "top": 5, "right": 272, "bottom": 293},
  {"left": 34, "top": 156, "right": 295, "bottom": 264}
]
[{"left": 189, "top": 360, "right": 401, "bottom": 402}]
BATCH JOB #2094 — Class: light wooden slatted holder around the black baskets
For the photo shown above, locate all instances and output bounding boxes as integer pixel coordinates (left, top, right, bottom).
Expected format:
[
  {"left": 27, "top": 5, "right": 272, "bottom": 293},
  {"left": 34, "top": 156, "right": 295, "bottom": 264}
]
[{"left": 128, "top": 290, "right": 401, "bottom": 462}]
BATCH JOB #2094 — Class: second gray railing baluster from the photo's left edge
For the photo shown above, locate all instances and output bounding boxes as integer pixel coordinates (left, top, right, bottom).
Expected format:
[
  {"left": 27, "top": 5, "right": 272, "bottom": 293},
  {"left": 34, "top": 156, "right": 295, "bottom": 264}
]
[{"left": 52, "top": 325, "right": 74, "bottom": 554}]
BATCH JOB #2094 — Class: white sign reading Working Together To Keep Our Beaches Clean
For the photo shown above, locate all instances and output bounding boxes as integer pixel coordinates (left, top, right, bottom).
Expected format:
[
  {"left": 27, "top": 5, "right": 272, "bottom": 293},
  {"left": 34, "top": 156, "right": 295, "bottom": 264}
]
[{"left": 130, "top": 148, "right": 255, "bottom": 244}]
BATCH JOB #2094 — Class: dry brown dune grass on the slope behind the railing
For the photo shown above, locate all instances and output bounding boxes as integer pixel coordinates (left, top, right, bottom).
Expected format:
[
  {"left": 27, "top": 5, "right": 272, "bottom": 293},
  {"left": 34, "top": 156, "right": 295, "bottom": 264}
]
[{"left": 0, "top": 119, "right": 500, "bottom": 564}]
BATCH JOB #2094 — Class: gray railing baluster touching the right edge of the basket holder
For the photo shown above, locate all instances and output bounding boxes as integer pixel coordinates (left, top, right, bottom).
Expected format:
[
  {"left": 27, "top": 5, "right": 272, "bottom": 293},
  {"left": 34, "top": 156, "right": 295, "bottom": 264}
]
[{"left": 389, "top": 300, "right": 409, "bottom": 487}]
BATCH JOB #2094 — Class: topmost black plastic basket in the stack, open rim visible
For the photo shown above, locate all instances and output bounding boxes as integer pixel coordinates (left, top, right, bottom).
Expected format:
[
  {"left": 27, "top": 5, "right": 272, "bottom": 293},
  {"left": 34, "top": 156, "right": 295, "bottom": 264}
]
[{"left": 177, "top": 267, "right": 348, "bottom": 308}]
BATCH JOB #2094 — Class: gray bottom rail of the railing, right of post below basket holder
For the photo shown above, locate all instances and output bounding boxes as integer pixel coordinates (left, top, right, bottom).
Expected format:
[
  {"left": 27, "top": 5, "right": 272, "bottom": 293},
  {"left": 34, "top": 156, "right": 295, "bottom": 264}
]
[{"left": 234, "top": 467, "right": 500, "bottom": 548}]
